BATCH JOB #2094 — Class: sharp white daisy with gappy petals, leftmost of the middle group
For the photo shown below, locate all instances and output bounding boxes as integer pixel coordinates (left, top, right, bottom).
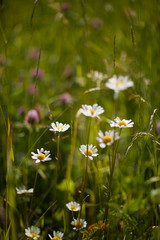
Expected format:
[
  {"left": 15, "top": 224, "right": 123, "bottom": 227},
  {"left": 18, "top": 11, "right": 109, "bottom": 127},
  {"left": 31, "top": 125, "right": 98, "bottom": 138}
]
[{"left": 31, "top": 148, "right": 52, "bottom": 163}]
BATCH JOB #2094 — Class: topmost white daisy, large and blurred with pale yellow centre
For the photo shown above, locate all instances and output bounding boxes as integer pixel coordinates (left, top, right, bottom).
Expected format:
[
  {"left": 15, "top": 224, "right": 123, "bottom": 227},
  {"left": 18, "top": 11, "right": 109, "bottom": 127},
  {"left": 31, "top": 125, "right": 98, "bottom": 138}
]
[{"left": 106, "top": 75, "right": 133, "bottom": 92}]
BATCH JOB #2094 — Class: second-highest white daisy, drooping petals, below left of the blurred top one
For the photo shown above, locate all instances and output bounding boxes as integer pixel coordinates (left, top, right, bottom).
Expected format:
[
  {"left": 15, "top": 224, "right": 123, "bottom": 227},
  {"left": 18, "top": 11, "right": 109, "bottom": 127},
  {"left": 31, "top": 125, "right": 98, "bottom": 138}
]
[{"left": 80, "top": 104, "right": 104, "bottom": 118}]
